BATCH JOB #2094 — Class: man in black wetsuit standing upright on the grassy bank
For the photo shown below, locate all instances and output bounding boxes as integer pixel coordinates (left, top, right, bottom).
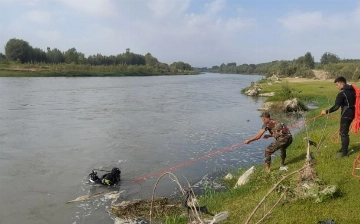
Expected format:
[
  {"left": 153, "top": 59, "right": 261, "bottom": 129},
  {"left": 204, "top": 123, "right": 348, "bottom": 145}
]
[{"left": 321, "top": 76, "right": 356, "bottom": 158}]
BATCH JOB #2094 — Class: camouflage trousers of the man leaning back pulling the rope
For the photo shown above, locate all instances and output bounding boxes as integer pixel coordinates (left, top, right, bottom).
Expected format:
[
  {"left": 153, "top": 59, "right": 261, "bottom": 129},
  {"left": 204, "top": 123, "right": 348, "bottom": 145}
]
[{"left": 265, "top": 135, "right": 292, "bottom": 165}]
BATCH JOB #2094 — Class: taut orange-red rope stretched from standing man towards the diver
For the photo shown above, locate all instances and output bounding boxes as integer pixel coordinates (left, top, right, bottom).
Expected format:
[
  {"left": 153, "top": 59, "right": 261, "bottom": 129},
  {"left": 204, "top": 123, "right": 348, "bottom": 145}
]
[{"left": 134, "top": 114, "right": 322, "bottom": 182}]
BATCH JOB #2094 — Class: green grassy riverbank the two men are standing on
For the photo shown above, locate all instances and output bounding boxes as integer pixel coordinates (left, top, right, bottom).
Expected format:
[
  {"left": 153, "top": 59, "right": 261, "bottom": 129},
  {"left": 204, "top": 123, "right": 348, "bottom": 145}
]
[{"left": 158, "top": 80, "right": 360, "bottom": 224}]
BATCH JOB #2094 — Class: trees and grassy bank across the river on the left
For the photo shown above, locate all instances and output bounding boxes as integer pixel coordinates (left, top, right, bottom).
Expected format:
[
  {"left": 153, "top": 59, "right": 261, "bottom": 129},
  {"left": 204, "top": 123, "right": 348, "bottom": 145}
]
[{"left": 0, "top": 39, "right": 199, "bottom": 77}]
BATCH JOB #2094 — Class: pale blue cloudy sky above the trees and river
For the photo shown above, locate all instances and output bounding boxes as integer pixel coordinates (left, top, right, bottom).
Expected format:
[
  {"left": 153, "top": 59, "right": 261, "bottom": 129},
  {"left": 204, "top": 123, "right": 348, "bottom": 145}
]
[{"left": 0, "top": 0, "right": 360, "bottom": 67}]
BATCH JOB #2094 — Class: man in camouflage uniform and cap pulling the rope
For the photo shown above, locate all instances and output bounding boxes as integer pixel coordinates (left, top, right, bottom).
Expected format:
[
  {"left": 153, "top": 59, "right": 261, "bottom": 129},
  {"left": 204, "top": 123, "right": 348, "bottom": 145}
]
[{"left": 244, "top": 112, "right": 292, "bottom": 172}]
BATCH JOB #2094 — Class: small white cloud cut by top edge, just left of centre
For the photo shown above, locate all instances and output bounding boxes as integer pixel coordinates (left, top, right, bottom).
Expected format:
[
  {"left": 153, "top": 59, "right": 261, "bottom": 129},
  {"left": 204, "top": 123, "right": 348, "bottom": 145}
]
[{"left": 147, "top": 0, "right": 190, "bottom": 18}]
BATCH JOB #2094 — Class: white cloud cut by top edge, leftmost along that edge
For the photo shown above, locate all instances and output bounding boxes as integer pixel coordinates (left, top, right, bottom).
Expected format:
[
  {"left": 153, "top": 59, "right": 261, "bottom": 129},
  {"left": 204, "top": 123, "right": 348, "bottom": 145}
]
[{"left": 58, "top": 0, "right": 116, "bottom": 17}]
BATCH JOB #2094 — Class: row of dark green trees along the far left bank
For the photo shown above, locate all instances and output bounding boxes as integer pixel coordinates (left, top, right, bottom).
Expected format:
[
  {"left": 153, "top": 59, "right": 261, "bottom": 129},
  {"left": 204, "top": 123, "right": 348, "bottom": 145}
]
[{"left": 0, "top": 38, "right": 192, "bottom": 71}]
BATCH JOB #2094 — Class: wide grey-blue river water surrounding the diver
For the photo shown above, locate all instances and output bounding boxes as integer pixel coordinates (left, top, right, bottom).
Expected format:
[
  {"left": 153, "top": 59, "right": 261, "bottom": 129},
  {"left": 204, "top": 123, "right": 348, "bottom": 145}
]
[{"left": 0, "top": 74, "right": 292, "bottom": 224}]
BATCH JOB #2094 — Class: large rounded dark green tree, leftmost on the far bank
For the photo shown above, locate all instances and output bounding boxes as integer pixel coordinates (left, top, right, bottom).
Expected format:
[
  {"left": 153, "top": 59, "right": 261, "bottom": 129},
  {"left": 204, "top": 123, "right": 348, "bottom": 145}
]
[{"left": 5, "top": 38, "right": 32, "bottom": 63}]
